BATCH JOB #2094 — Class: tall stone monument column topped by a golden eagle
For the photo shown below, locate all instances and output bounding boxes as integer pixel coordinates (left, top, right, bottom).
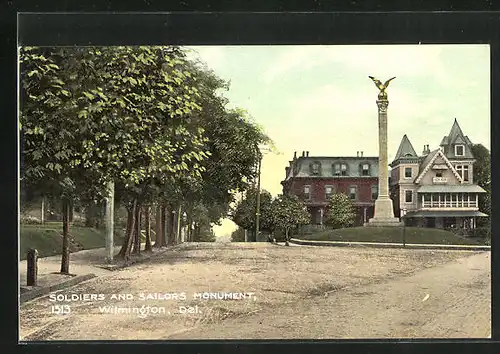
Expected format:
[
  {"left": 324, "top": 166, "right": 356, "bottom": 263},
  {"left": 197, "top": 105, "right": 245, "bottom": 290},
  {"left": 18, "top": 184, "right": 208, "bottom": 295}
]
[{"left": 365, "top": 76, "right": 402, "bottom": 226}]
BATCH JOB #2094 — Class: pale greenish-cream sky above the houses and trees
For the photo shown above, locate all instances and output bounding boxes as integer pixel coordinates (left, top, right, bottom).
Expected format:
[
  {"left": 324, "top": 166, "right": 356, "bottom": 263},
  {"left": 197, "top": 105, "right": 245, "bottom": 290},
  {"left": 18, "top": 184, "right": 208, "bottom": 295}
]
[{"left": 186, "top": 45, "right": 490, "bottom": 236}]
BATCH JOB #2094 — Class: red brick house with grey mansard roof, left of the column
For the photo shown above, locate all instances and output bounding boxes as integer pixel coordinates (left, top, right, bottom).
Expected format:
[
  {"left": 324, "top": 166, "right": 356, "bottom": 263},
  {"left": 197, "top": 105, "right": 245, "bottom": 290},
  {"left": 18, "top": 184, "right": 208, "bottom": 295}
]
[{"left": 281, "top": 151, "right": 378, "bottom": 225}]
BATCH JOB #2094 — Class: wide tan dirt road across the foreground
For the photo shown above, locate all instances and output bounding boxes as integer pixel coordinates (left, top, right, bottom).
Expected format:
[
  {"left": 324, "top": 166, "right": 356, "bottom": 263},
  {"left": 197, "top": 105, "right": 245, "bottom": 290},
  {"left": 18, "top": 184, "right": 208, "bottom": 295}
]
[{"left": 20, "top": 243, "right": 491, "bottom": 341}]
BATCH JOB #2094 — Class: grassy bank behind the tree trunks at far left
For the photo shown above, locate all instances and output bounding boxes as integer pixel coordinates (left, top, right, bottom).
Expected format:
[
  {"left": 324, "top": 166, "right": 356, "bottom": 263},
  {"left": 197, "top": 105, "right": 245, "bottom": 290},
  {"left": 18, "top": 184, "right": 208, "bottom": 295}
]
[{"left": 19, "top": 222, "right": 121, "bottom": 260}]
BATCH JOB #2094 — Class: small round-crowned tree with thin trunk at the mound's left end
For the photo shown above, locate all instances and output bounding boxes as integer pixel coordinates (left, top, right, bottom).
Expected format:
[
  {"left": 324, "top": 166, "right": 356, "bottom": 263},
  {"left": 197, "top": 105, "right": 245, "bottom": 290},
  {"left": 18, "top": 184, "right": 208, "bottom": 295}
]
[{"left": 272, "top": 194, "right": 310, "bottom": 246}]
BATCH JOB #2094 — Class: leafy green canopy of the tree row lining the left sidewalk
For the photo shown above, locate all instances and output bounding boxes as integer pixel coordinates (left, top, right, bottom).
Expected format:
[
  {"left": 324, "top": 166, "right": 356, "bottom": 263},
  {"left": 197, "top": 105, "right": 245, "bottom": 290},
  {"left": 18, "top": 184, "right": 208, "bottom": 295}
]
[{"left": 20, "top": 46, "right": 273, "bottom": 254}]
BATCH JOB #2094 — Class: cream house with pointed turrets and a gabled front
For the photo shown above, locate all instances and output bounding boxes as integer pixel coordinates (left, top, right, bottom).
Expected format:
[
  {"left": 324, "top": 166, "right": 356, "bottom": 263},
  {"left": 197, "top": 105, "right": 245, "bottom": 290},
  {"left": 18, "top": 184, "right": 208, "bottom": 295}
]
[{"left": 390, "top": 119, "right": 487, "bottom": 228}]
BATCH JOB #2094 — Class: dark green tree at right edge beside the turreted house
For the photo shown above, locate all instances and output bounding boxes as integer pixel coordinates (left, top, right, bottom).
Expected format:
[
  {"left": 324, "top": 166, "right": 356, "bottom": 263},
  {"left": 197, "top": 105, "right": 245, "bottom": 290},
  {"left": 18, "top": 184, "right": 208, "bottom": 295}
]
[{"left": 472, "top": 144, "right": 491, "bottom": 225}]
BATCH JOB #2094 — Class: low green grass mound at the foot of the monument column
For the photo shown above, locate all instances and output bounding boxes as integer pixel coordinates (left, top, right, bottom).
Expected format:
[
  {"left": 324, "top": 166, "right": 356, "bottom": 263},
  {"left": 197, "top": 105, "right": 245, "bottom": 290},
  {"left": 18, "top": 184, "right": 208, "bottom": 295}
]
[{"left": 295, "top": 227, "right": 484, "bottom": 245}]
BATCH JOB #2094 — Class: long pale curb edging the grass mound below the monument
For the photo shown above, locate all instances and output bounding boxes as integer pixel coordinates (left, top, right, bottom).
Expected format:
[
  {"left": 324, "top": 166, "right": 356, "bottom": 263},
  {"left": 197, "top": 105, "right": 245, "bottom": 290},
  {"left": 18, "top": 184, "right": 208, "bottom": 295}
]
[{"left": 290, "top": 238, "right": 491, "bottom": 251}]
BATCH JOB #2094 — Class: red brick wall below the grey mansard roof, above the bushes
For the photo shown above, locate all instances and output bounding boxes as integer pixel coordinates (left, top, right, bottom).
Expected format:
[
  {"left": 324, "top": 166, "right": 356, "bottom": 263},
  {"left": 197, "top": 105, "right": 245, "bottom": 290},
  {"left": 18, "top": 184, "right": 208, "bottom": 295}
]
[{"left": 285, "top": 177, "right": 378, "bottom": 203}]
